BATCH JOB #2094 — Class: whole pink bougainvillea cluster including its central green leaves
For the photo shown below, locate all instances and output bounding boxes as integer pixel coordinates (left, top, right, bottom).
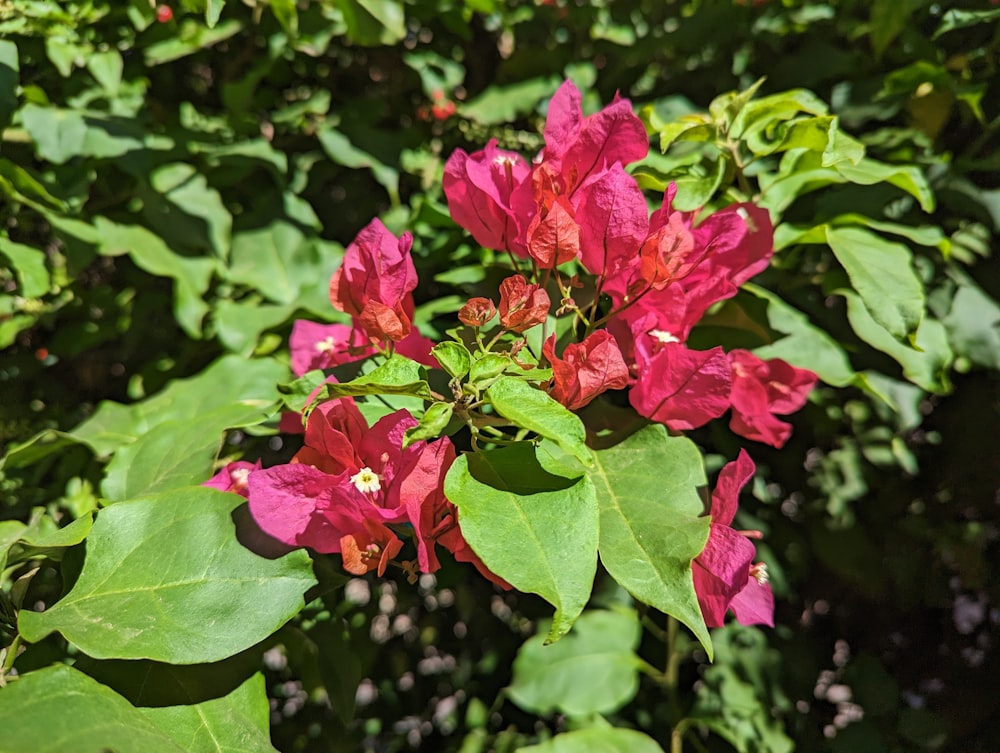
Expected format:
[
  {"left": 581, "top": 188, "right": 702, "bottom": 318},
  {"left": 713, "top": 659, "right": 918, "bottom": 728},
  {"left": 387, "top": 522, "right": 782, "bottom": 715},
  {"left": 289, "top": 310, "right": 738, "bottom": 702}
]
[{"left": 210, "top": 82, "right": 817, "bottom": 653}]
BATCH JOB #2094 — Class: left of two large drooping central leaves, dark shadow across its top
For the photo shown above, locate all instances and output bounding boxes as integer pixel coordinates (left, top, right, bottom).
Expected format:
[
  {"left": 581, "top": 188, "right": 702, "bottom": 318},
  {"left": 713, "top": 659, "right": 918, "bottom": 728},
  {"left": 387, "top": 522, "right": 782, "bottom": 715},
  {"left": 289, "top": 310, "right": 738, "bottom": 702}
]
[{"left": 444, "top": 443, "right": 598, "bottom": 642}]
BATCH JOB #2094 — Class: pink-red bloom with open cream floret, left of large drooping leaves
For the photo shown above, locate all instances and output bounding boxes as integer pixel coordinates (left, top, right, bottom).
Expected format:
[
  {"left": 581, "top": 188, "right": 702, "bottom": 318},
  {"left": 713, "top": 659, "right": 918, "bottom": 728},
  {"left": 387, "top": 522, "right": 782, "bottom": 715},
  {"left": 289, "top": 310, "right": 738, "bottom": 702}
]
[{"left": 248, "top": 398, "right": 501, "bottom": 582}]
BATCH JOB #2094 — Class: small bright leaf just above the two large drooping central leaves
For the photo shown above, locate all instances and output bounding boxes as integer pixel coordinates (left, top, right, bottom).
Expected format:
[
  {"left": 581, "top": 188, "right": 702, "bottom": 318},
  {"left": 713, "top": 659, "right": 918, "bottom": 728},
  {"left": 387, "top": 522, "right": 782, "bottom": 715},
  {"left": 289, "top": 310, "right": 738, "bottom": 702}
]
[{"left": 486, "top": 376, "right": 594, "bottom": 468}]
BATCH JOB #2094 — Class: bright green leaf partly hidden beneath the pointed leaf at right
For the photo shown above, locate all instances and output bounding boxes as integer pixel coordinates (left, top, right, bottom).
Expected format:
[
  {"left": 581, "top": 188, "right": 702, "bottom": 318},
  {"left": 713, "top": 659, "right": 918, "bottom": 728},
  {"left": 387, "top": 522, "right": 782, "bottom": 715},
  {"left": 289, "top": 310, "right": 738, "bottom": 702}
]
[{"left": 837, "top": 290, "right": 953, "bottom": 394}]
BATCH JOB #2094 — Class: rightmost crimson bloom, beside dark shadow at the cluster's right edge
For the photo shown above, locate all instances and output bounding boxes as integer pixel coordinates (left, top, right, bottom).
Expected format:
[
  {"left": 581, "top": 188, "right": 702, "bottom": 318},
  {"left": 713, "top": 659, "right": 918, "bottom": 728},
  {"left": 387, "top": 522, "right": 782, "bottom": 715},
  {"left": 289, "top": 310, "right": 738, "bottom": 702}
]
[{"left": 729, "top": 350, "right": 819, "bottom": 447}]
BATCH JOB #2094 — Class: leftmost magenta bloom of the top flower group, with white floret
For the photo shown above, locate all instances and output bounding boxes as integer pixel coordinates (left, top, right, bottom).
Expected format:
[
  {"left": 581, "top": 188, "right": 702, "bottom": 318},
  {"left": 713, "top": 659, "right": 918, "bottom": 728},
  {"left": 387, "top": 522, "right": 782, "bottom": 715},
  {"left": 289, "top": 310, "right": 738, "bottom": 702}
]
[{"left": 443, "top": 139, "right": 530, "bottom": 256}]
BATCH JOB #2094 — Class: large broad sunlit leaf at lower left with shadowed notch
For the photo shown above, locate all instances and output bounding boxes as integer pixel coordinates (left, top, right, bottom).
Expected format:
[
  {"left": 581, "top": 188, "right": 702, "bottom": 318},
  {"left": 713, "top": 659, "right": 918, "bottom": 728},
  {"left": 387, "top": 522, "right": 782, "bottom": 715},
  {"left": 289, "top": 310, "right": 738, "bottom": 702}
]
[{"left": 19, "top": 487, "right": 316, "bottom": 656}]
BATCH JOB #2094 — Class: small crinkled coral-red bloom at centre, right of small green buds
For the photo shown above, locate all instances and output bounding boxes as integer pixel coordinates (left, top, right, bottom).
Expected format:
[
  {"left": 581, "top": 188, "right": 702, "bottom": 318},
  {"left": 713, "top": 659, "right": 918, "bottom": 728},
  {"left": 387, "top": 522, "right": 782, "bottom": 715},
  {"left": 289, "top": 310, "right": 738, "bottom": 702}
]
[{"left": 542, "top": 329, "right": 628, "bottom": 410}]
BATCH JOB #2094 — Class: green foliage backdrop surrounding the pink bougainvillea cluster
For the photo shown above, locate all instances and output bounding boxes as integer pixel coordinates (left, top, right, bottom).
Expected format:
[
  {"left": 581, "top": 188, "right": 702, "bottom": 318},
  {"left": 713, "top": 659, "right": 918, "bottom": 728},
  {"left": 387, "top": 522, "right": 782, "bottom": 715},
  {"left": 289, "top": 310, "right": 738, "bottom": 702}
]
[{"left": 0, "top": 0, "right": 1000, "bottom": 751}]
